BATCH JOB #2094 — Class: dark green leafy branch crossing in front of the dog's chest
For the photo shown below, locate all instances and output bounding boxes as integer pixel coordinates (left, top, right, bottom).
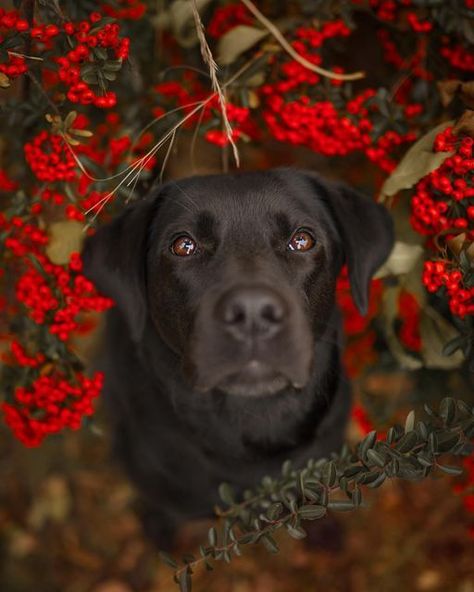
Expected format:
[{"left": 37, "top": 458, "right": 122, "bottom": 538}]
[{"left": 161, "top": 397, "right": 474, "bottom": 592}]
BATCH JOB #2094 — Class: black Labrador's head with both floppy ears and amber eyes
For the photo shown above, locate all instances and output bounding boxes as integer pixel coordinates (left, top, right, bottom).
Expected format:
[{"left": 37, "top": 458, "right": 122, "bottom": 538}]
[{"left": 83, "top": 169, "right": 393, "bottom": 395}]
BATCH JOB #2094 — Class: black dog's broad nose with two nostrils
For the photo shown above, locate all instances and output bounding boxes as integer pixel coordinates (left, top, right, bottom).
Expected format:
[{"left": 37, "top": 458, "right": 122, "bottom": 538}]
[{"left": 216, "top": 286, "right": 287, "bottom": 340}]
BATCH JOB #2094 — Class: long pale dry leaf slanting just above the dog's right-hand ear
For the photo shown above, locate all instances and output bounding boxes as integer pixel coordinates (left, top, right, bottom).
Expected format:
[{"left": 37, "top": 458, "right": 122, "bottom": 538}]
[{"left": 379, "top": 121, "right": 453, "bottom": 202}]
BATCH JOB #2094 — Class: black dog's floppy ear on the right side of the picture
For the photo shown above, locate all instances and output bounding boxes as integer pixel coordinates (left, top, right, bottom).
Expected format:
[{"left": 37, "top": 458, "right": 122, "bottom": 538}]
[{"left": 308, "top": 173, "right": 394, "bottom": 314}]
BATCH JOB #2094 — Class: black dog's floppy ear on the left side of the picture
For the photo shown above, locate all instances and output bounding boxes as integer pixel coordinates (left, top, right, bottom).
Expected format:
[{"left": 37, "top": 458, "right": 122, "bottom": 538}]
[{"left": 82, "top": 194, "right": 157, "bottom": 341}]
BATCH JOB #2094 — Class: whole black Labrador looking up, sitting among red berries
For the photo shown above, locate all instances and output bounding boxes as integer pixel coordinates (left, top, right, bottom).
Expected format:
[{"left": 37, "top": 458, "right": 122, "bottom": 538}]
[{"left": 84, "top": 169, "right": 393, "bottom": 546}]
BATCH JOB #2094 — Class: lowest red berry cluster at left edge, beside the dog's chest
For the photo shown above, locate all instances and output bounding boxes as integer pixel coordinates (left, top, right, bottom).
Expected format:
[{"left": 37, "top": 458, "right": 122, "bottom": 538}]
[{"left": 1, "top": 372, "right": 104, "bottom": 447}]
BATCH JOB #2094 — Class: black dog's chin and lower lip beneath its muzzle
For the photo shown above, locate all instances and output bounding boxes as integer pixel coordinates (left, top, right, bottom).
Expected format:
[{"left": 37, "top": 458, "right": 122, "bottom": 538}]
[{"left": 215, "top": 360, "right": 290, "bottom": 397}]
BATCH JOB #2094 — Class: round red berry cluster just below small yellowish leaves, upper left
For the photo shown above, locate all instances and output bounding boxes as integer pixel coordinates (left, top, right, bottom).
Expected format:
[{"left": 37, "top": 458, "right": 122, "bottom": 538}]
[{"left": 24, "top": 130, "right": 76, "bottom": 182}]
